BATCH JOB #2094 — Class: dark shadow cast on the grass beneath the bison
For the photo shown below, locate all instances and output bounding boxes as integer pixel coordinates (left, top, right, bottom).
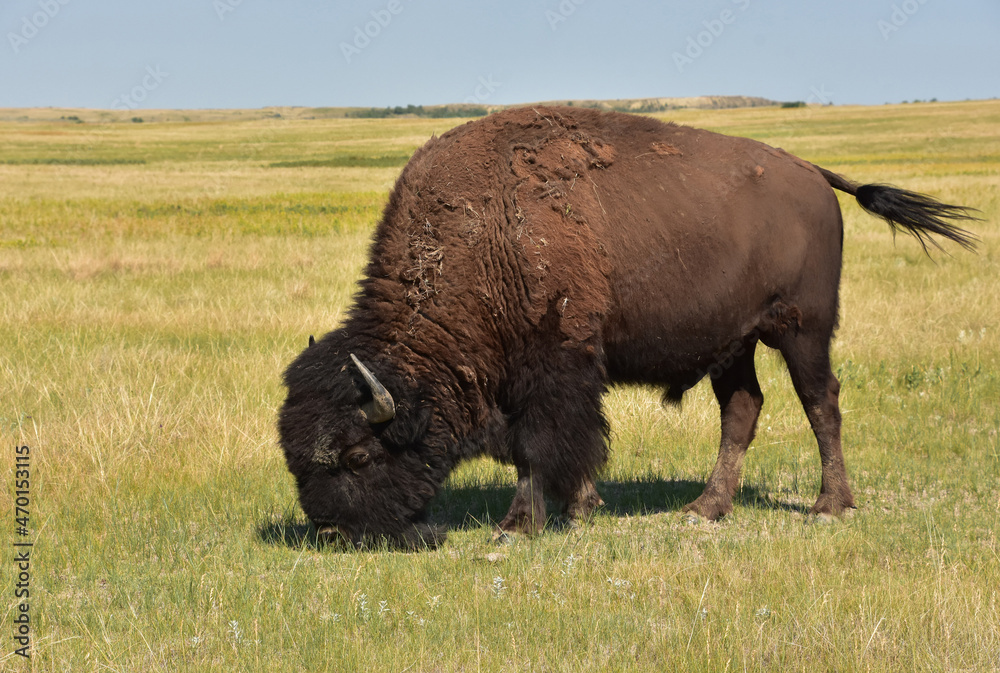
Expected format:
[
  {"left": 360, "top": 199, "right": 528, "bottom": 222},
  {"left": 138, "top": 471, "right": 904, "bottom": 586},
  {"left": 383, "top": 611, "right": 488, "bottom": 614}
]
[{"left": 257, "top": 479, "right": 809, "bottom": 551}]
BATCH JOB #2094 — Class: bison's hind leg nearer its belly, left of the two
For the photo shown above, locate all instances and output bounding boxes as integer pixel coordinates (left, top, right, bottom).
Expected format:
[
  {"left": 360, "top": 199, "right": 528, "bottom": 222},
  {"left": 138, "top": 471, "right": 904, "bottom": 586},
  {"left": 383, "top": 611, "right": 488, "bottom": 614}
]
[{"left": 684, "top": 341, "right": 764, "bottom": 521}]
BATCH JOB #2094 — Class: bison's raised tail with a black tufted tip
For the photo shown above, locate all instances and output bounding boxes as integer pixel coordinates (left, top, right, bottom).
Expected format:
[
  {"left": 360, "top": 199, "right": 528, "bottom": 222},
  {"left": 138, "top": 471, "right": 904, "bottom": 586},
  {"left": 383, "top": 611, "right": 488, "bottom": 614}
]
[{"left": 816, "top": 166, "right": 980, "bottom": 252}]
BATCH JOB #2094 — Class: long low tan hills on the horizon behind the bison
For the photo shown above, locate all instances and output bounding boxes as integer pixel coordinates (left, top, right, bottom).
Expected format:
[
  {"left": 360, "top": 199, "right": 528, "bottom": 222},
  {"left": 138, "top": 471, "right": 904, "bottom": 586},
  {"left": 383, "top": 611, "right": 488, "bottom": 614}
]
[{"left": 0, "top": 96, "right": 781, "bottom": 124}]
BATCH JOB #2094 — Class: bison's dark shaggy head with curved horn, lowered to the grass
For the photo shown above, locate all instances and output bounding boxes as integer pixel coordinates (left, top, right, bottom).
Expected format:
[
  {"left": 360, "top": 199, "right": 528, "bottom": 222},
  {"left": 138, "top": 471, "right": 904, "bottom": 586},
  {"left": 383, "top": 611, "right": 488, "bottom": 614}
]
[{"left": 278, "top": 335, "right": 447, "bottom": 548}]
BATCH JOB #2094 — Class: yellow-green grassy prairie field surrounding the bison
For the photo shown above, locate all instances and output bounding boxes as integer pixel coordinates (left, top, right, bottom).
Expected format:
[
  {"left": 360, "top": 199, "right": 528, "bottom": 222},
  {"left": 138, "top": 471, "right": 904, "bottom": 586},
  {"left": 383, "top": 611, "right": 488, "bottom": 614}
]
[{"left": 0, "top": 101, "right": 1000, "bottom": 673}]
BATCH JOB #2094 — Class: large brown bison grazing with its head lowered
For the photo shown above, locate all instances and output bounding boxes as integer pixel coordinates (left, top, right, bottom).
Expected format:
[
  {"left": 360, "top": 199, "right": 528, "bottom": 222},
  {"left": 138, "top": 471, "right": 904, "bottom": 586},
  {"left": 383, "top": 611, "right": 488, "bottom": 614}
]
[{"left": 278, "top": 107, "right": 976, "bottom": 548}]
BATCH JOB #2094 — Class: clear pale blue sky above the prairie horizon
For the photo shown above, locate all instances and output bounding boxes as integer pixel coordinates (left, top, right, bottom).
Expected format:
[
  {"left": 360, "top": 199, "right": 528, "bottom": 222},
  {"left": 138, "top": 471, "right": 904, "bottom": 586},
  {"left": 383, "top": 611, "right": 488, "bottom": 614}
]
[{"left": 0, "top": 0, "right": 1000, "bottom": 109}]
